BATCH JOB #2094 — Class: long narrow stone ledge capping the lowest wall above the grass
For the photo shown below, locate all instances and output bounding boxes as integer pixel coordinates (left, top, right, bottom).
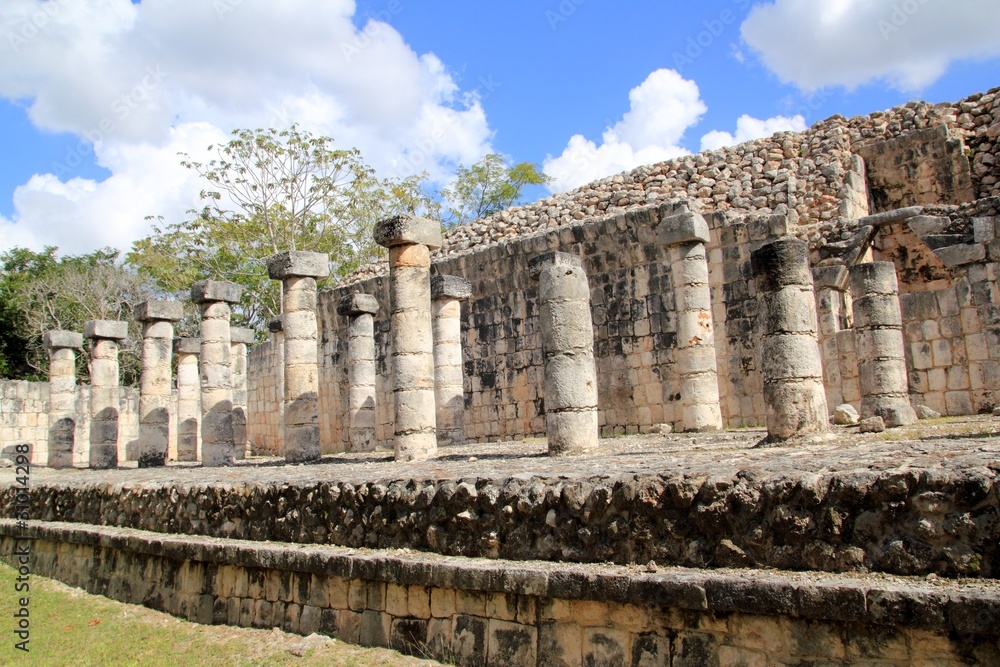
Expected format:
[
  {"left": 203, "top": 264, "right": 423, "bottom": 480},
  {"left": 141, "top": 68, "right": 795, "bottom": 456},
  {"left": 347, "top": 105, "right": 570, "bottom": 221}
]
[{"left": 0, "top": 519, "right": 1000, "bottom": 637}]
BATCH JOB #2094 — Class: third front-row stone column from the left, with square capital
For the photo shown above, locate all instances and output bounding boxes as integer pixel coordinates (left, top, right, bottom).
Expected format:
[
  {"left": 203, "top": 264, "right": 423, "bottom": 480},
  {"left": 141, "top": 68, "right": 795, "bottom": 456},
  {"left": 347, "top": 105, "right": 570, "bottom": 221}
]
[{"left": 134, "top": 301, "right": 184, "bottom": 468}]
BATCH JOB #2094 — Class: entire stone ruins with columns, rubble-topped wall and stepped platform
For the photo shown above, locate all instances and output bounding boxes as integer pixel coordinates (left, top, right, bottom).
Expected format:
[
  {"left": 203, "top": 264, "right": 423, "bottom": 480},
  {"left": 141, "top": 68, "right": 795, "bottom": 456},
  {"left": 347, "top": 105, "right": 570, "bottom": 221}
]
[{"left": 0, "top": 89, "right": 1000, "bottom": 667}]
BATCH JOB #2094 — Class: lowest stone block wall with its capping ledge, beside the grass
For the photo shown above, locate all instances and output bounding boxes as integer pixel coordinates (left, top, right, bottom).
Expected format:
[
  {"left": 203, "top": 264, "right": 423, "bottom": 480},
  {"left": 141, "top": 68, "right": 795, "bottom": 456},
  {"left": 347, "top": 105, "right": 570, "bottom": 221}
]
[{"left": 0, "top": 521, "right": 1000, "bottom": 667}]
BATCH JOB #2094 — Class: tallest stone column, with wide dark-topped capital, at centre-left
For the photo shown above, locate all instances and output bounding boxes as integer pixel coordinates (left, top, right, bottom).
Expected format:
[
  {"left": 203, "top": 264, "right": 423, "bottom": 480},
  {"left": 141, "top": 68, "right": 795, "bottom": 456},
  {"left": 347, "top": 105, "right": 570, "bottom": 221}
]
[{"left": 374, "top": 216, "right": 442, "bottom": 461}]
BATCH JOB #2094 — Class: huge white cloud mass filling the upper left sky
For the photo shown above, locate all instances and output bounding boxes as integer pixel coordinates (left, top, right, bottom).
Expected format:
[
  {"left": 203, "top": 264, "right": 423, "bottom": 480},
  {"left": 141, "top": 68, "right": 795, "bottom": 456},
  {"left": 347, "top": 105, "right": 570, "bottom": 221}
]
[{"left": 0, "top": 0, "right": 492, "bottom": 252}]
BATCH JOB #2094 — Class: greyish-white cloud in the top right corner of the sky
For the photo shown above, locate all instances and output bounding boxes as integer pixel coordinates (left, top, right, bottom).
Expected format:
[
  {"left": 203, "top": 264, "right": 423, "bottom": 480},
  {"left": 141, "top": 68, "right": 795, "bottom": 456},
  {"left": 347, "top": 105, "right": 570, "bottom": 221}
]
[{"left": 742, "top": 0, "right": 1000, "bottom": 91}]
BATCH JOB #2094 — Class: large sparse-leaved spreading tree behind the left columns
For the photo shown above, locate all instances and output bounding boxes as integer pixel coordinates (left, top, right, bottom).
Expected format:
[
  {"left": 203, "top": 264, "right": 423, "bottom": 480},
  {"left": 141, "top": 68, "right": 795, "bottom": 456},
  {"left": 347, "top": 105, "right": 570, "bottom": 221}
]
[{"left": 128, "top": 125, "right": 431, "bottom": 331}]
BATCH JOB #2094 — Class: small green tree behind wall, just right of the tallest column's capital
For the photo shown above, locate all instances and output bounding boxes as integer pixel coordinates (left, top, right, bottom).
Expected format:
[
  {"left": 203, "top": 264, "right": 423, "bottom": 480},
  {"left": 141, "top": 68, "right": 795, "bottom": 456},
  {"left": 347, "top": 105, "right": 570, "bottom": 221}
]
[{"left": 441, "top": 153, "right": 552, "bottom": 224}]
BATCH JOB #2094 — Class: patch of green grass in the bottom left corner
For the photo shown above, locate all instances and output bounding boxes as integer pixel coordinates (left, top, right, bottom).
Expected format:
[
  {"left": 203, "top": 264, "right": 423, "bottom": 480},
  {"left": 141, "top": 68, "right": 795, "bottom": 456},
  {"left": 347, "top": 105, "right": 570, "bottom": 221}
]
[{"left": 0, "top": 564, "right": 439, "bottom": 667}]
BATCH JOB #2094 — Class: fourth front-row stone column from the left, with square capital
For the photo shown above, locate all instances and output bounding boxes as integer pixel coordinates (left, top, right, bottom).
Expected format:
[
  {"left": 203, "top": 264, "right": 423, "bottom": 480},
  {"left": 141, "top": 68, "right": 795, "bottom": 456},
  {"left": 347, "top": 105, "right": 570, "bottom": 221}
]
[{"left": 191, "top": 280, "right": 243, "bottom": 466}]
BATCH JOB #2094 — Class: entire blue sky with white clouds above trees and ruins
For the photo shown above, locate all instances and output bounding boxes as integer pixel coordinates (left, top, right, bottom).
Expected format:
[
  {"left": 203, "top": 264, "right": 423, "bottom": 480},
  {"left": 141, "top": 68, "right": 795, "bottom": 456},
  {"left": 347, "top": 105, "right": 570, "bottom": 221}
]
[{"left": 0, "top": 0, "right": 1000, "bottom": 253}]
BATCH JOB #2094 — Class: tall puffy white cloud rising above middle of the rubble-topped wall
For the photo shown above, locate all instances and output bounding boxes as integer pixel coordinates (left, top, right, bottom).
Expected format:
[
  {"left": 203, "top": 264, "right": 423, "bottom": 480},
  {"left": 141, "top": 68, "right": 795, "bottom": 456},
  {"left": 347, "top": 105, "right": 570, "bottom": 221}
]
[{"left": 544, "top": 69, "right": 708, "bottom": 192}]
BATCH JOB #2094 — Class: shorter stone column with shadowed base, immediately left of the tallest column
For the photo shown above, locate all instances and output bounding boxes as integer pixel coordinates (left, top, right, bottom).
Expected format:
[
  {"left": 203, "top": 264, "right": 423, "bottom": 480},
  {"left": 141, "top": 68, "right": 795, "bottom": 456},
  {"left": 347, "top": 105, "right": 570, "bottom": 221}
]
[{"left": 337, "top": 293, "right": 378, "bottom": 452}]
